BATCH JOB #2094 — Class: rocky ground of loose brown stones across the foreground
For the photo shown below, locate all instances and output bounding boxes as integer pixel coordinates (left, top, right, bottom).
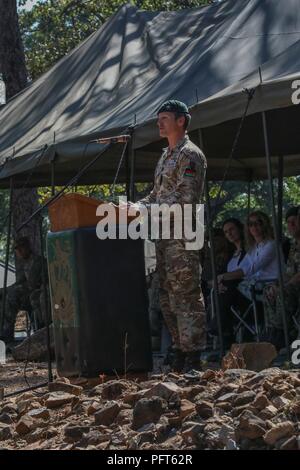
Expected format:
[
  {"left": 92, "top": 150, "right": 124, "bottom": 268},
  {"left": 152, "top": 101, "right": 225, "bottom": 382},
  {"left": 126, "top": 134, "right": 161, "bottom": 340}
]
[{"left": 0, "top": 362, "right": 300, "bottom": 450}]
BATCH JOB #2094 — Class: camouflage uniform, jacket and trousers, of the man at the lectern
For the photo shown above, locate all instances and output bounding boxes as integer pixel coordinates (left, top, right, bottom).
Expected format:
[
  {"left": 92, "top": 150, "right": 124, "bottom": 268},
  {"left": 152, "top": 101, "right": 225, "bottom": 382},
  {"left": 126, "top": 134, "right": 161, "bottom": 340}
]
[{"left": 139, "top": 135, "right": 206, "bottom": 352}]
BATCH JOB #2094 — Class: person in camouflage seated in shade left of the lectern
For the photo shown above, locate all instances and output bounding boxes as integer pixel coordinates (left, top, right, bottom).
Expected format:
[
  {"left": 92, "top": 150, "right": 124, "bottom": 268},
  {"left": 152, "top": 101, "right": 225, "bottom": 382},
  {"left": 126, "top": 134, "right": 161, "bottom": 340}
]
[{"left": 1, "top": 237, "right": 45, "bottom": 342}]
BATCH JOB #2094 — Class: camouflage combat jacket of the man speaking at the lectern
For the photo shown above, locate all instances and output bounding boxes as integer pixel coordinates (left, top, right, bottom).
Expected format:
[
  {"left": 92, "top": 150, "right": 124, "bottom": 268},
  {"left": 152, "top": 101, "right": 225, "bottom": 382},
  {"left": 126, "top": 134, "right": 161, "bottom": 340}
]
[{"left": 139, "top": 134, "right": 207, "bottom": 208}]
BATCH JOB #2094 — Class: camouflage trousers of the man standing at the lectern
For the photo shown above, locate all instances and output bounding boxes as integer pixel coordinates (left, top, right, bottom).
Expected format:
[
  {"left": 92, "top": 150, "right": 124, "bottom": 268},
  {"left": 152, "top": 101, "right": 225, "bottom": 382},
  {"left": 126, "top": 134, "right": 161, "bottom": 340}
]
[{"left": 156, "top": 240, "right": 206, "bottom": 352}]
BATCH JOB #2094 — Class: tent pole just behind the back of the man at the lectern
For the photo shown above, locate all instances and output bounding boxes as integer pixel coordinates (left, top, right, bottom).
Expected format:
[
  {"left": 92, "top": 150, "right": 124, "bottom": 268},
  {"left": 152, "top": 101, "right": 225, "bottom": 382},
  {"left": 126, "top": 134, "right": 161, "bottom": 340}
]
[{"left": 198, "top": 129, "right": 224, "bottom": 359}]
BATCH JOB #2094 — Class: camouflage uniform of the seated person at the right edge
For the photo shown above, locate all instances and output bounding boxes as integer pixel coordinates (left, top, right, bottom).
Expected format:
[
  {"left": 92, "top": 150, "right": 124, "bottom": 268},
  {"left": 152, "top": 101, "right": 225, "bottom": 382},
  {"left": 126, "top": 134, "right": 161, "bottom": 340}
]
[{"left": 263, "top": 240, "right": 300, "bottom": 329}]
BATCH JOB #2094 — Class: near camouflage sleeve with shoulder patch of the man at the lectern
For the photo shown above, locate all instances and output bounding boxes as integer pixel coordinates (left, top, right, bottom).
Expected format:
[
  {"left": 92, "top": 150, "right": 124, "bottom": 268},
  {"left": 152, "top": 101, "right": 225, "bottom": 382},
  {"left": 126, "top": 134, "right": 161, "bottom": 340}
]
[{"left": 165, "top": 151, "right": 206, "bottom": 205}]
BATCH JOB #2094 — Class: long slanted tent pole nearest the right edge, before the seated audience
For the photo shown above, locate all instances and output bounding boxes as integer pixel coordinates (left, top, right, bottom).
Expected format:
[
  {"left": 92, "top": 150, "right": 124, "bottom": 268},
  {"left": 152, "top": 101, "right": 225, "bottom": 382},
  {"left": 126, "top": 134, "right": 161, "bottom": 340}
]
[{"left": 262, "top": 111, "right": 291, "bottom": 359}]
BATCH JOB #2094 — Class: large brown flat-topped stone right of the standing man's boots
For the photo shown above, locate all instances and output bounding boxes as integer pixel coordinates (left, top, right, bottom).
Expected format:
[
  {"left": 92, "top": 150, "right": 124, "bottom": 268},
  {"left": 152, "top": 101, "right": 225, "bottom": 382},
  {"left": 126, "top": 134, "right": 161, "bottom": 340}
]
[{"left": 222, "top": 343, "right": 277, "bottom": 371}]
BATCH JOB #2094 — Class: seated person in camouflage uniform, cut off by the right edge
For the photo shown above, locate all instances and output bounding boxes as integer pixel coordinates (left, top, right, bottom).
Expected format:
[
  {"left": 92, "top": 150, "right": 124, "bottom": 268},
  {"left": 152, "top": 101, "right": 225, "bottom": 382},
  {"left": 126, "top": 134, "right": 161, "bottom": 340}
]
[{"left": 263, "top": 207, "right": 300, "bottom": 349}]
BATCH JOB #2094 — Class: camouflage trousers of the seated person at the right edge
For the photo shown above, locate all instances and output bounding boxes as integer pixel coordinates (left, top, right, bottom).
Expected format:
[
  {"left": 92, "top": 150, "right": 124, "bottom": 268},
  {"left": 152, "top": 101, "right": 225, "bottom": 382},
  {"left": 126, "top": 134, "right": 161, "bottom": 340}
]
[{"left": 263, "top": 284, "right": 300, "bottom": 330}]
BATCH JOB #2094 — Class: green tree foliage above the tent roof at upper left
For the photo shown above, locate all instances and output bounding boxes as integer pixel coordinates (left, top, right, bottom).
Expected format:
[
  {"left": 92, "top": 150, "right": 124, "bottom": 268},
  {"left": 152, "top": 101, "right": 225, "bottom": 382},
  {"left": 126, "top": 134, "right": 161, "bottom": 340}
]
[{"left": 19, "top": 0, "right": 210, "bottom": 80}]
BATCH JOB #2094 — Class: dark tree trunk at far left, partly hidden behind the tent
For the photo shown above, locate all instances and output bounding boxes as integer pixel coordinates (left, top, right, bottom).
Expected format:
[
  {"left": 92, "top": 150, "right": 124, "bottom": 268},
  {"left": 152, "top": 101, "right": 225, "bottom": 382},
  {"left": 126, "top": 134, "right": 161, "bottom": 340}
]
[{"left": 0, "top": 0, "right": 40, "bottom": 260}]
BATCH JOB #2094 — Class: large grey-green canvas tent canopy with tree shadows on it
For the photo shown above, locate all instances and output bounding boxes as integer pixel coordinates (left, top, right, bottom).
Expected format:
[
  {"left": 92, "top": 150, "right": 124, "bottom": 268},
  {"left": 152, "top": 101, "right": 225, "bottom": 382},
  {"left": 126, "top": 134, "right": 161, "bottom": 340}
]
[{"left": 0, "top": 0, "right": 300, "bottom": 187}]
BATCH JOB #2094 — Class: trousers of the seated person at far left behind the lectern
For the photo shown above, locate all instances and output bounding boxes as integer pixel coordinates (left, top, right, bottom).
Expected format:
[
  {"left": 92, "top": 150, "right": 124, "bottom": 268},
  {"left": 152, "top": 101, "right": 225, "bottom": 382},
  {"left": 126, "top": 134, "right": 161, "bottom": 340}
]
[{"left": 1, "top": 284, "right": 45, "bottom": 338}]
